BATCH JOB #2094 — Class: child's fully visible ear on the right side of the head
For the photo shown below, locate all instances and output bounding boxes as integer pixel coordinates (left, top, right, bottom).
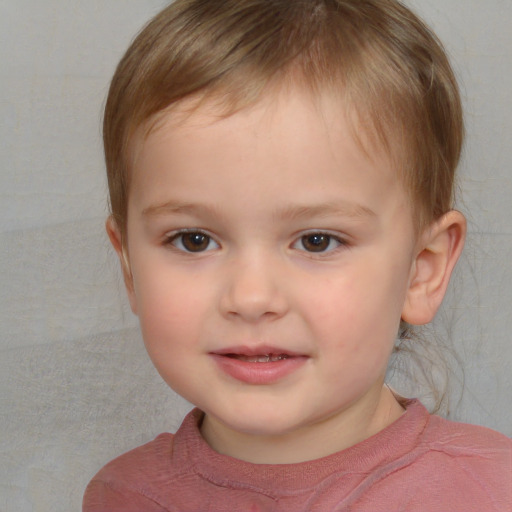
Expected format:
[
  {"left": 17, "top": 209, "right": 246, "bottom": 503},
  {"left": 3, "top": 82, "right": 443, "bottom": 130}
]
[{"left": 402, "top": 210, "right": 466, "bottom": 325}]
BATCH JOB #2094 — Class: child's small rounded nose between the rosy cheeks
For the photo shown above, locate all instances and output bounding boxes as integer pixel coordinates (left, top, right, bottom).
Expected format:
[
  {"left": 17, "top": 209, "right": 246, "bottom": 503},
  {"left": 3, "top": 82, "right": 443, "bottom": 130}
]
[{"left": 220, "top": 255, "right": 288, "bottom": 323}]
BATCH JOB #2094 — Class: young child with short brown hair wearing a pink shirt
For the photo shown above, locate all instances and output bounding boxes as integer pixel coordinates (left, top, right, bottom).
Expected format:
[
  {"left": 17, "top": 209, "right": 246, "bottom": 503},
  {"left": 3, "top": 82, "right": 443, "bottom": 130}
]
[{"left": 83, "top": 0, "right": 512, "bottom": 512}]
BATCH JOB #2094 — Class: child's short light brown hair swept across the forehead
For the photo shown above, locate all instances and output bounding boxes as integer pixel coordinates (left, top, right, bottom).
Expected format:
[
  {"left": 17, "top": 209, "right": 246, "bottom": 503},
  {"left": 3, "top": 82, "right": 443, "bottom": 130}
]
[{"left": 103, "top": 0, "right": 463, "bottom": 237}]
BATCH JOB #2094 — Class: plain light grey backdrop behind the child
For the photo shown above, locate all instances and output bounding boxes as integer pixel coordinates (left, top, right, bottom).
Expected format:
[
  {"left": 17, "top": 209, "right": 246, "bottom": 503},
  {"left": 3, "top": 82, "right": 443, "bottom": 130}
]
[{"left": 0, "top": 0, "right": 512, "bottom": 512}]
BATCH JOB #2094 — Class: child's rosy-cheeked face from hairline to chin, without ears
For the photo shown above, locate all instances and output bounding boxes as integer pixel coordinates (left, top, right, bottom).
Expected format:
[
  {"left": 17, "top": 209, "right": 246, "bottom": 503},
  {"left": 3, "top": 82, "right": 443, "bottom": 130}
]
[{"left": 121, "top": 91, "right": 415, "bottom": 464}]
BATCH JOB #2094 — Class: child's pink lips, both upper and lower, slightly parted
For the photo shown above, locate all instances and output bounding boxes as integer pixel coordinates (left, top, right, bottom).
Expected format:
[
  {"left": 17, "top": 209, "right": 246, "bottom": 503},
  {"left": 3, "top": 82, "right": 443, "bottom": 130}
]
[{"left": 210, "top": 345, "right": 309, "bottom": 385}]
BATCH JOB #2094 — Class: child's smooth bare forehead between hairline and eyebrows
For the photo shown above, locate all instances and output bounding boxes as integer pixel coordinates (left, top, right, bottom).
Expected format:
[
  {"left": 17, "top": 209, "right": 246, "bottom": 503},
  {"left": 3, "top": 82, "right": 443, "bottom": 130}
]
[{"left": 130, "top": 85, "right": 412, "bottom": 225}]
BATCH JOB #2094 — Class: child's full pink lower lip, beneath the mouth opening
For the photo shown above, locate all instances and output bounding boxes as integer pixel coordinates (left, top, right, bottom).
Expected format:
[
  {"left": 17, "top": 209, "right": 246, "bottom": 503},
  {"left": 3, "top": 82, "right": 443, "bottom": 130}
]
[{"left": 212, "top": 354, "right": 308, "bottom": 384}]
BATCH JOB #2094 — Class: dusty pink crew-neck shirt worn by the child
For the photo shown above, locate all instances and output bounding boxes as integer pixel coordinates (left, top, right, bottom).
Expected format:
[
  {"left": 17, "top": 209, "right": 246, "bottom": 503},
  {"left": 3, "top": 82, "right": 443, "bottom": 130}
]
[{"left": 83, "top": 400, "right": 512, "bottom": 512}]
